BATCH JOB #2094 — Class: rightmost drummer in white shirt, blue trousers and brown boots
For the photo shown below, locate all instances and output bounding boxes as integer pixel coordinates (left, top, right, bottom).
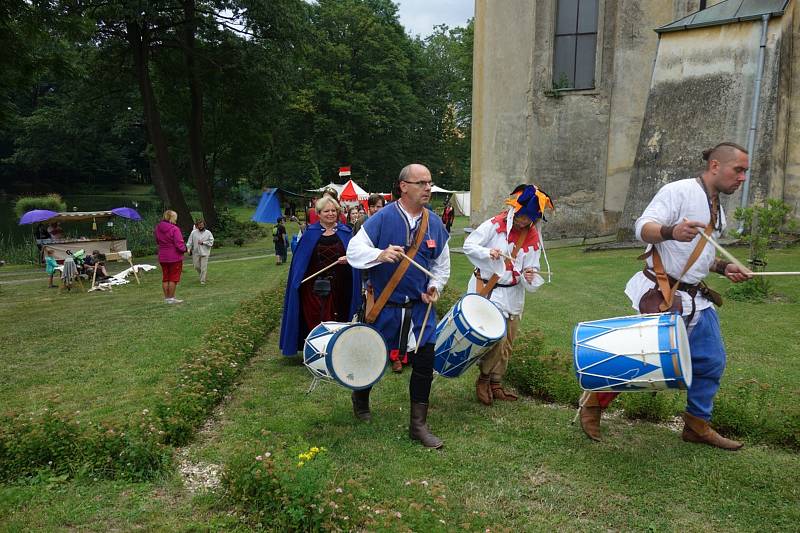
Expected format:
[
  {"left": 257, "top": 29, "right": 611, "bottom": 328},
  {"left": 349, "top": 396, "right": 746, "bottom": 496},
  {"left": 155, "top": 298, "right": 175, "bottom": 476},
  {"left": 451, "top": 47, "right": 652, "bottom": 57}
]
[{"left": 580, "top": 142, "right": 752, "bottom": 450}]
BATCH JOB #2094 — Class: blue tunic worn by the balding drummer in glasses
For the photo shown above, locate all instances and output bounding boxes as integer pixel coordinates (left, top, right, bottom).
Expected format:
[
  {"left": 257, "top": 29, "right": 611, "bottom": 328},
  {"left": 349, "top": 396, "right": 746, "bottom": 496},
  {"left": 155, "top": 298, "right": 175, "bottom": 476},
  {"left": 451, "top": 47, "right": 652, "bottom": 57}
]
[{"left": 362, "top": 202, "right": 450, "bottom": 350}]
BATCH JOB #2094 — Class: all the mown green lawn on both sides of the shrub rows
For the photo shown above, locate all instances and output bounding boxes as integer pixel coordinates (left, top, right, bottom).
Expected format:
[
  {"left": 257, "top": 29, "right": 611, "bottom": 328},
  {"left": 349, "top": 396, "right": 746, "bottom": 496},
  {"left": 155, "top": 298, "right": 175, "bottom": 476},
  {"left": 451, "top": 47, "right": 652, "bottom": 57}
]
[{"left": 0, "top": 215, "right": 800, "bottom": 531}]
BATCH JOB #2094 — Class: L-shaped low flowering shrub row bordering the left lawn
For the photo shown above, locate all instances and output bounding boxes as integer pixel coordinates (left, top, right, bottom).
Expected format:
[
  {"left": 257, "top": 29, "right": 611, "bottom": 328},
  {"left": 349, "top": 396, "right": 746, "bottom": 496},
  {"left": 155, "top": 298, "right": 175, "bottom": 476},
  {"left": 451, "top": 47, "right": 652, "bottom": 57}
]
[{"left": 0, "top": 280, "right": 283, "bottom": 481}]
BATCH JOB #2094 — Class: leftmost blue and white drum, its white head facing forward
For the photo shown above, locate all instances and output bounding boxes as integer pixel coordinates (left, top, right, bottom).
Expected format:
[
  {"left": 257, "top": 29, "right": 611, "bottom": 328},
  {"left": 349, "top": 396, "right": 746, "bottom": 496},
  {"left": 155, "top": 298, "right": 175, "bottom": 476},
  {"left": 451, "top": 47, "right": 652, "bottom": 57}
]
[{"left": 303, "top": 322, "right": 387, "bottom": 390}]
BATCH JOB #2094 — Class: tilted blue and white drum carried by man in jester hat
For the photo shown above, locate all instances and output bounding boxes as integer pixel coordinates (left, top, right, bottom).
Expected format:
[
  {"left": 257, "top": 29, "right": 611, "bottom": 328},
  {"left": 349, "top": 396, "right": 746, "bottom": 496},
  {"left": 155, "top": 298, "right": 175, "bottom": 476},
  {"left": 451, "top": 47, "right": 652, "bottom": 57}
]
[{"left": 433, "top": 293, "right": 506, "bottom": 378}]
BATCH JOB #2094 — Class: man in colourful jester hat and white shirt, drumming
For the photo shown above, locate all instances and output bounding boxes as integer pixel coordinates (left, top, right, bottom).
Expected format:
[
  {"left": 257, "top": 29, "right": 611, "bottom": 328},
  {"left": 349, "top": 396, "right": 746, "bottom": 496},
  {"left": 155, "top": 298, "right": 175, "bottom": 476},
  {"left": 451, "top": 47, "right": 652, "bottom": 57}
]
[{"left": 464, "top": 185, "right": 553, "bottom": 405}]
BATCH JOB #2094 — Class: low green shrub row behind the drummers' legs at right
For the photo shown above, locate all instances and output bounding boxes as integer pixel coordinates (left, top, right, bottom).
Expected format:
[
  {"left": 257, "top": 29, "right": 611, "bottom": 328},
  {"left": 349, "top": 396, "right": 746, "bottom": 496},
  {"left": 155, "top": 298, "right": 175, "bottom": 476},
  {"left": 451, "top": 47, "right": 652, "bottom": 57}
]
[{"left": 507, "top": 331, "right": 800, "bottom": 449}]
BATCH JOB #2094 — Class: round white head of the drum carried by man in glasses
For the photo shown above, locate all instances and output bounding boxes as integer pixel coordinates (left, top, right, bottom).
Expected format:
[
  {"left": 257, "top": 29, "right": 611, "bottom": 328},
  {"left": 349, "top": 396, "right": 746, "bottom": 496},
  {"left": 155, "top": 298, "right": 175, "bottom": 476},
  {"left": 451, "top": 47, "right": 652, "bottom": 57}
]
[{"left": 325, "top": 324, "right": 387, "bottom": 390}]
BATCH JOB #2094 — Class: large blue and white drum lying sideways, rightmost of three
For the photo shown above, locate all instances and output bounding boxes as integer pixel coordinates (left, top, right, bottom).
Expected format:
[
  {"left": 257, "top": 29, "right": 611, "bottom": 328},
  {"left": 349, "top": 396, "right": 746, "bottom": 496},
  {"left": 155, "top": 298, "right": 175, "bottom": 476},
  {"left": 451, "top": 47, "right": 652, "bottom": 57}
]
[{"left": 573, "top": 313, "right": 692, "bottom": 391}]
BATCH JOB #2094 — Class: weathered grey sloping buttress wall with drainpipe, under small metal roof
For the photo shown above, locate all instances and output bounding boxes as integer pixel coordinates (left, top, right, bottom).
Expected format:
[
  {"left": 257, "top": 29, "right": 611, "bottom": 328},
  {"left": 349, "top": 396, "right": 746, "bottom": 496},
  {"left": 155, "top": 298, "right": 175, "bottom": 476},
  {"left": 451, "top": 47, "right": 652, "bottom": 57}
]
[{"left": 620, "top": 17, "right": 791, "bottom": 238}]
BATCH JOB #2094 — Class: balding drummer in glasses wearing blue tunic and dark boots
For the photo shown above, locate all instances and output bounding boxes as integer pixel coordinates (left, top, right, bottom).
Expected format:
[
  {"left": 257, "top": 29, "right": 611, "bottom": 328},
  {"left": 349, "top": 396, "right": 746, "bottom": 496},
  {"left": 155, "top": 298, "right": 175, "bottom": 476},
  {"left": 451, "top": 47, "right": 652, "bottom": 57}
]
[{"left": 347, "top": 164, "right": 450, "bottom": 448}]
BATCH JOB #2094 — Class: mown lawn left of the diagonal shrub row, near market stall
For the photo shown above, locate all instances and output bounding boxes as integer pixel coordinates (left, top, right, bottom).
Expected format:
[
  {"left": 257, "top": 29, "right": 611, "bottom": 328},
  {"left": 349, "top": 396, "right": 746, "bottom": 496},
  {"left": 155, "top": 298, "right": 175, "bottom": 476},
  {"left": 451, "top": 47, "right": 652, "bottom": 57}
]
[{"left": 0, "top": 244, "right": 285, "bottom": 421}]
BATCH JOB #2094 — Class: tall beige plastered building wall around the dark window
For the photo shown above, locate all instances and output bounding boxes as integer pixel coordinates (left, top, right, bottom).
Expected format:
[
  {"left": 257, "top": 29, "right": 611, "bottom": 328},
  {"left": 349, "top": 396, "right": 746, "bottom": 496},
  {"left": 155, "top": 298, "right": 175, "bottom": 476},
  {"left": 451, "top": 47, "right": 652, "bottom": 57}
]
[{"left": 471, "top": 0, "right": 677, "bottom": 236}]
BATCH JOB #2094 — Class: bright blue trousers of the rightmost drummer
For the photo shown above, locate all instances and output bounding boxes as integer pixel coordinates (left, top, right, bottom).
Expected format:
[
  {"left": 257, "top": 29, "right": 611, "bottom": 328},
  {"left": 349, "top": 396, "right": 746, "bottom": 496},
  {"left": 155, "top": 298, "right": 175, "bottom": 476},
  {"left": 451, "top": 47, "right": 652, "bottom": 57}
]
[{"left": 686, "top": 307, "right": 726, "bottom": 420}]
